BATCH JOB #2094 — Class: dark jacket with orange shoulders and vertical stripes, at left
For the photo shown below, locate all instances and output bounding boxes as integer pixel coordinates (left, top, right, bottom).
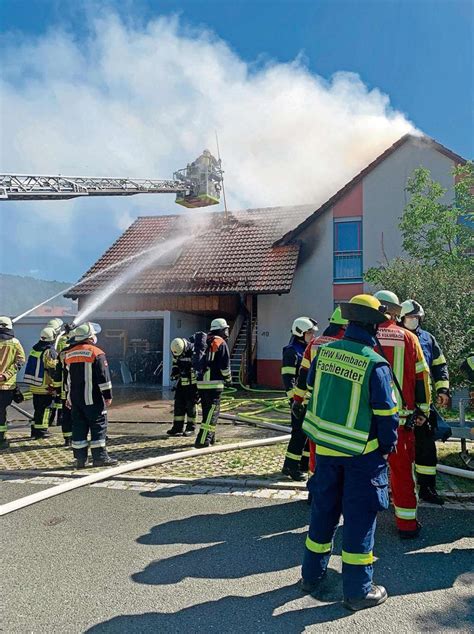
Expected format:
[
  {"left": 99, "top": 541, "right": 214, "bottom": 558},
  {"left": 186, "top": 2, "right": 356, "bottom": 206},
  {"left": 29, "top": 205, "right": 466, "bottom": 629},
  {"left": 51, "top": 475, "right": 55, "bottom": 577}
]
[{"left": 64, "top": 343, "right": 112, "bottom": 405}]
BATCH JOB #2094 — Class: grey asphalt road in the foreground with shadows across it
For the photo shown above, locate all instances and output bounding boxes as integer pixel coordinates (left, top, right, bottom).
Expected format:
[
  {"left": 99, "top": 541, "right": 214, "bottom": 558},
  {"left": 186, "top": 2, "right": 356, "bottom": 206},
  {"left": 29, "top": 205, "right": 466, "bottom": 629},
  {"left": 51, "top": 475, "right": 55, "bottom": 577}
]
[{"left": 0, "top": 483, "right": 474, "bottom": 634}]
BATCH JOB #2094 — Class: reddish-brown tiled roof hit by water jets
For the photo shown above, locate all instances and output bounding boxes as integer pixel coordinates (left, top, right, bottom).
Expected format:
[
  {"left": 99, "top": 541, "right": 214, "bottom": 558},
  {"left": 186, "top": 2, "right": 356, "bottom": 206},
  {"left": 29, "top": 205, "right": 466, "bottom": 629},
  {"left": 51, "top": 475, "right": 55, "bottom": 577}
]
[{"left": 67, "top": 205, "right": 314, "bottom": 297}]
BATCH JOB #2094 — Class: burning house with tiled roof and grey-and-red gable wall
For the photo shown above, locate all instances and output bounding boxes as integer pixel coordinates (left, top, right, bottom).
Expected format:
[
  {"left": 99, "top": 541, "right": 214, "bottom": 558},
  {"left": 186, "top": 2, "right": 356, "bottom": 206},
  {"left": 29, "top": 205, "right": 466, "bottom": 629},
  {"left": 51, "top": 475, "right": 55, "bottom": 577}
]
[{"left": 67, "top": 135, "right": 465, "bottom": 387}]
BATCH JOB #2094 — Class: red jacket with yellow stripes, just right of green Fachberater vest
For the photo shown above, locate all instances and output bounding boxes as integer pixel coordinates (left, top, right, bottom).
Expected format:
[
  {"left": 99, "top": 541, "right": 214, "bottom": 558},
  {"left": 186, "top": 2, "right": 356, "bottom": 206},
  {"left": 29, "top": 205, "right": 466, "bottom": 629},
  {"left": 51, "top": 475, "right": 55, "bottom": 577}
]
[{"left": 375, "top": 320, "right": 431, "bottom": 418}]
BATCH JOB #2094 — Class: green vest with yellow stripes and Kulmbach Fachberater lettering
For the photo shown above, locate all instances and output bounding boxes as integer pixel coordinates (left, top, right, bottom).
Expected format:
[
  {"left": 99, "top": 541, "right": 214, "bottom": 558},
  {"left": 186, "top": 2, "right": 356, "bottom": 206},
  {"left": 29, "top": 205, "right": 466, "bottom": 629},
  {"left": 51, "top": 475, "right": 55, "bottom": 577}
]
[{"left": 303, "top": 339, "right": 388, "bottom": 456}]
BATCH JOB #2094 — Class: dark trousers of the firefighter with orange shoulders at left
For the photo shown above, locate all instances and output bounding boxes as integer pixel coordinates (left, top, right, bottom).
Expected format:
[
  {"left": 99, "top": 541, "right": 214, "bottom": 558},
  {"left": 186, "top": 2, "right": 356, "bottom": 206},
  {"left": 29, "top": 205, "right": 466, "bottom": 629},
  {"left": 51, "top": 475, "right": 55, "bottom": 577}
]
[{"left": 71, "top": 403, "right": 107, "bottom": 462}]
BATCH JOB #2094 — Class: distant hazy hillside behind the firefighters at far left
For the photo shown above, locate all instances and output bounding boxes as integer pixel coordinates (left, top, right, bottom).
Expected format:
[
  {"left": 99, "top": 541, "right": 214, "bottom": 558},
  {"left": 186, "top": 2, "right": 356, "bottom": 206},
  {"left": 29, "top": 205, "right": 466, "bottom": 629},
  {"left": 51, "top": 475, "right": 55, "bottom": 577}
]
[{"left": 0, "top": 273, "right": 76, "bottom": 316}]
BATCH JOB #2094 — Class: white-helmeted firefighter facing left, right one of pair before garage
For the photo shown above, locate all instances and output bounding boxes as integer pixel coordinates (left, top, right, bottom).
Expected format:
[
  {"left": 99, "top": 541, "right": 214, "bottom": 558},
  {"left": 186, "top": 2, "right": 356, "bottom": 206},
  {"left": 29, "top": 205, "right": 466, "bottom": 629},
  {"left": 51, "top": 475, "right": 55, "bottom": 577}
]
[{"left": 194, "top": 318, "right": 232, "bottom": 449}]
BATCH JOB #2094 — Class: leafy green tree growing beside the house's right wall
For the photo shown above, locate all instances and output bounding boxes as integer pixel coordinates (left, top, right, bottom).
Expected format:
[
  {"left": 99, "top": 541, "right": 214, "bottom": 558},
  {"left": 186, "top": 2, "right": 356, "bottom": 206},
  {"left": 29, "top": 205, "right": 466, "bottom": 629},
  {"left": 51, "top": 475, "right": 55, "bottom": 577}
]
[{"left": 365, "top": 163, "right": 474, "bottom": 387}]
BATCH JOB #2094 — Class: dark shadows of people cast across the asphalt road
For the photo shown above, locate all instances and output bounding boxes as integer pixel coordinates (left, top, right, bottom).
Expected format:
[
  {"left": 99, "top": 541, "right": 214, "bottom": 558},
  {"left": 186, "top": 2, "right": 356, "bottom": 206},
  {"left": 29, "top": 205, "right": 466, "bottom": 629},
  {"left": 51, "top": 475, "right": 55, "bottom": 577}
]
[{"left": 88, "top": 492, "right": 474, "bottom": 633}]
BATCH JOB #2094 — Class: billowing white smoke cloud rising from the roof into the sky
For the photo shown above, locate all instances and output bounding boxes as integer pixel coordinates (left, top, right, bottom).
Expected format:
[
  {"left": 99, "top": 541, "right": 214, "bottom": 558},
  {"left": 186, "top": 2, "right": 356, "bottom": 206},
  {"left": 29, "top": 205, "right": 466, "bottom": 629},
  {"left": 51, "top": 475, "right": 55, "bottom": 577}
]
[{"left": 0, "top": 14, "right": 413, "bottom": 275}]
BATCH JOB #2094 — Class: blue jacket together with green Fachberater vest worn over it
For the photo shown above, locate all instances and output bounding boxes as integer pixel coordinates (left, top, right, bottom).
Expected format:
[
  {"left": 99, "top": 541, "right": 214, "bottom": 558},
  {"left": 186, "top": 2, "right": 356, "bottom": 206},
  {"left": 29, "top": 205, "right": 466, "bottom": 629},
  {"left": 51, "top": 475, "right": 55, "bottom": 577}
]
[{"left": 303, "top": 324, "right": 398, "bottom": 457}]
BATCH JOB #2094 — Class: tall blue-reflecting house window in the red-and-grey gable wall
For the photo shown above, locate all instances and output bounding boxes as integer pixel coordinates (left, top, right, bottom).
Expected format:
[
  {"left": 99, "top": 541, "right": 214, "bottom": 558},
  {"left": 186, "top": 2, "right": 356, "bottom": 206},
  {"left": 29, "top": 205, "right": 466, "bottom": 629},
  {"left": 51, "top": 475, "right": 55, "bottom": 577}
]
[{"left": 334, "top": 218, "right": 362, "bottom": 282}]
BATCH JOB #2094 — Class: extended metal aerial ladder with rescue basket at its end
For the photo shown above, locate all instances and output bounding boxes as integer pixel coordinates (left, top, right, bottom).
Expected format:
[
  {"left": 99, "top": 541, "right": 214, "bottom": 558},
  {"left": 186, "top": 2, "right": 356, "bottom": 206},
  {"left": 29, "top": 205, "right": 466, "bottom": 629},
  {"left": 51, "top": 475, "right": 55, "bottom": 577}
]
[{"left": 0, "top": 150, "right": 223, "bottom": 208}]
